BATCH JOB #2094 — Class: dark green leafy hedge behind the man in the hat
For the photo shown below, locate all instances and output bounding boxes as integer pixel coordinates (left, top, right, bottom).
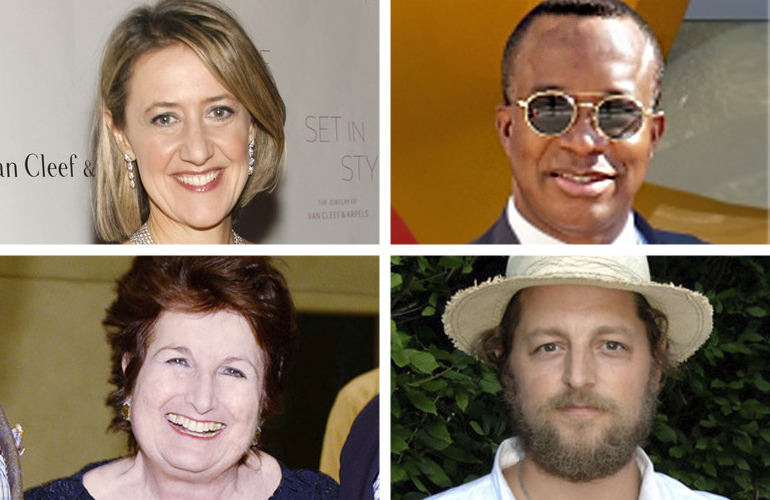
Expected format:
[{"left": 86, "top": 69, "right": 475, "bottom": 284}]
[{"left": 391, "top": 257, "right": 770, "bottom": 500}]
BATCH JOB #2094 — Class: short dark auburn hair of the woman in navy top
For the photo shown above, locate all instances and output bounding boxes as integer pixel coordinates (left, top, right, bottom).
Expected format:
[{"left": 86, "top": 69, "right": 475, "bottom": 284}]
[{"left": 102, "top": 256, "right": 297, "bottom": 452}]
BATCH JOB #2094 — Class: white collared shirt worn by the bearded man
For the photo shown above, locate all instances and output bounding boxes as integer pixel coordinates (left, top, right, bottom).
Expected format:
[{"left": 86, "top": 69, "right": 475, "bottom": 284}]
[{"left": 427, "top": 438, "right": 727, "bottom": 500}]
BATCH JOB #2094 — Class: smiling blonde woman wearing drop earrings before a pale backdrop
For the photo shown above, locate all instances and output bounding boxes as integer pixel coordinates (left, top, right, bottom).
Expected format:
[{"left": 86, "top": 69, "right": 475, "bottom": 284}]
[{"left": 94, "top": 0, "right": 286, "bottom": 244}]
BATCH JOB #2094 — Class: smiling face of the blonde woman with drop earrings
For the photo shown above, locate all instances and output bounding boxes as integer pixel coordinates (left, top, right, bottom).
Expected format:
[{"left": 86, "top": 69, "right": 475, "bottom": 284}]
[{"left": 114, "top": 44, "right": 256, "bottom": 230}]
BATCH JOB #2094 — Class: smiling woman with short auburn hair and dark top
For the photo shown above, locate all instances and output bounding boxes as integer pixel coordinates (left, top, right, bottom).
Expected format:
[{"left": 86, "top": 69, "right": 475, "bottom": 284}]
[{"left": 26, "top": 257, "right": 337, "bottom": 500}]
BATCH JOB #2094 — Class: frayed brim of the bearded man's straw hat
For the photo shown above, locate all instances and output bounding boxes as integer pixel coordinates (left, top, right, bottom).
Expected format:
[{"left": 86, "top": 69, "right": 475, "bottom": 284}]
[{"left": 443, "top": 274, "right": 712, "bottom": 362}]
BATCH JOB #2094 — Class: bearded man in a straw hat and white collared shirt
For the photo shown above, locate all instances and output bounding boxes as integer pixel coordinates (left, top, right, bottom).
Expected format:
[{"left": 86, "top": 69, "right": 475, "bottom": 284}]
[{"left": 432, "top": 256, "right": 722, "bottom": 500}]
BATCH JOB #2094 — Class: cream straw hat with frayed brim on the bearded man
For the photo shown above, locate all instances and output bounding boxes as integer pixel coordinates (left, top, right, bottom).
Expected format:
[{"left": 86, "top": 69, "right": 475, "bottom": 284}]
[{"left": 443, "top": 255, "right": 712, "bottom": 362}]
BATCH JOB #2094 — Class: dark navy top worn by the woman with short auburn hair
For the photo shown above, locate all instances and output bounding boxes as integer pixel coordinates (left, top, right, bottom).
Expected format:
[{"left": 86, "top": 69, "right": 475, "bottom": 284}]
[{"left": 24, "top": 462, "right": 339, "bottom": 500}]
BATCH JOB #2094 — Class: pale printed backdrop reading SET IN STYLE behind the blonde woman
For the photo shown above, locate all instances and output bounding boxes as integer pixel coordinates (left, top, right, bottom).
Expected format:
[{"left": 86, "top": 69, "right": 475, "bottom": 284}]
[{"left": 0, "top": 0, "right": 380, "bottom": 243}]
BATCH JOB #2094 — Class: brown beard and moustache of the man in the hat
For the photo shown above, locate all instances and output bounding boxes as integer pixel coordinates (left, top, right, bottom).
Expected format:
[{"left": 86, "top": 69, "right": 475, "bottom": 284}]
[{"left": 502, "top": 368, "right": 659, "bottom": 483}]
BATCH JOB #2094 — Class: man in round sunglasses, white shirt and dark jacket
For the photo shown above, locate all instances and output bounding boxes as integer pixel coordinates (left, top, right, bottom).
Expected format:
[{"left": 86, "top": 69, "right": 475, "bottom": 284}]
[{"left": 473, "top": 0, "right": 702, "bottom": 245}]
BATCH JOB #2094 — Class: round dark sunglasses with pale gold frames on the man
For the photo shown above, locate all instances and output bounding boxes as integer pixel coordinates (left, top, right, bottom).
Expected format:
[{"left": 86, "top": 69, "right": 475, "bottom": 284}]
[{"left": 516, "top": 90, "right": 653, "bottom": 141}]
